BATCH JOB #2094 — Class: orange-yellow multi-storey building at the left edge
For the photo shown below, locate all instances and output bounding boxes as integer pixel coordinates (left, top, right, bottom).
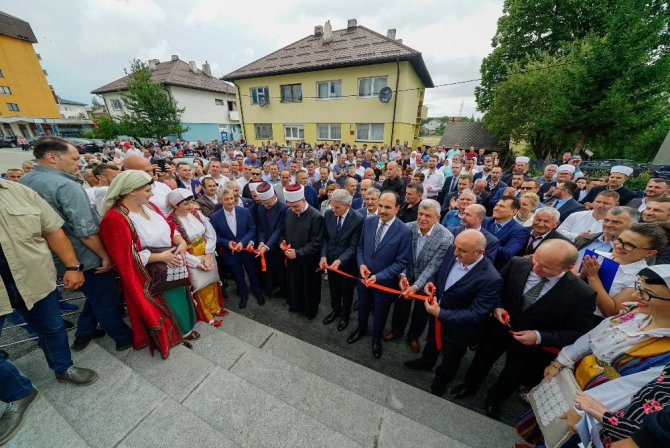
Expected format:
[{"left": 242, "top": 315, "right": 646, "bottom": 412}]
[{"left": 0, "top": 12, "right": 60, "bottom": 137}]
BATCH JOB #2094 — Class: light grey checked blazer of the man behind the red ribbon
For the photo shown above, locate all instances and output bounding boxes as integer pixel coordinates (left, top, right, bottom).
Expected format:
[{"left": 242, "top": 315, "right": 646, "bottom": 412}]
[{"left": 405, "top": 221, "right": 454, "bottom": 291}]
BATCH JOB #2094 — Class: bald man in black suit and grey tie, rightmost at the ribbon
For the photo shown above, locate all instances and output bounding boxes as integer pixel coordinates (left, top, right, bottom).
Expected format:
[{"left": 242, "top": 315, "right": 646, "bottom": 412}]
[{"left": 452, "top": 239, "right": 596, "bottom": 419}]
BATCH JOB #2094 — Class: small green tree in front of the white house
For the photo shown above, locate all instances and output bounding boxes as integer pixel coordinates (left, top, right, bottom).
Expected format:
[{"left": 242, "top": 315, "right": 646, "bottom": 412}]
[{"left": 119, "top": 59, "right": 188, "bottom": 140}]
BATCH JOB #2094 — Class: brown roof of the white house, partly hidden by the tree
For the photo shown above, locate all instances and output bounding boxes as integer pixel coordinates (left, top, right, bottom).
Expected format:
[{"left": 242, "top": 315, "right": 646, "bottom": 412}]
[{"left": 91, "top": 59, "right": 237, "bottom": 95}]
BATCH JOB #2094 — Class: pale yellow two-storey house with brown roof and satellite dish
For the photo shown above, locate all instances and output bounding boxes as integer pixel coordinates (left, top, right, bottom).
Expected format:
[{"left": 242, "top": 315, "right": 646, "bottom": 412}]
[{"left": 222, "top": 19, "right": 433, "bottom": 146}]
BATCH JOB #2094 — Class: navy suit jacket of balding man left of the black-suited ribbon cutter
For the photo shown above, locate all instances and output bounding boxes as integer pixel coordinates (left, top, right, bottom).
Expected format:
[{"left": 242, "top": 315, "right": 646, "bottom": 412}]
[{"left": 435, "top": 252, "right": 503, "bottom": 345}]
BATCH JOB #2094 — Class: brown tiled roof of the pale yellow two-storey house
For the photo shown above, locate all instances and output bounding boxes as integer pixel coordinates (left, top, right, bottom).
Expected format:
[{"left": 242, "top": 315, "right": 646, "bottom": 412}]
[{"left": 221, "top": 26, "right": 433, "bottom": 87}]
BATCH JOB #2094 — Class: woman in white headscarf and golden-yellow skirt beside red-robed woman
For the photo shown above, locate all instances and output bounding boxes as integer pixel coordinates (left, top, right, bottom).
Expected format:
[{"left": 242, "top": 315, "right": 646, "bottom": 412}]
[{"left": 166, "top": 188, "right": 228, "bottom": 327}]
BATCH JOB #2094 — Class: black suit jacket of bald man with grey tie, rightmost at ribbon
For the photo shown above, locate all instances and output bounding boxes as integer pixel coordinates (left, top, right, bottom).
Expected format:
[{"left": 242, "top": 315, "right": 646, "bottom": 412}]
[{"left": 498, "top": 257, "right": 596, "bottom": 347}]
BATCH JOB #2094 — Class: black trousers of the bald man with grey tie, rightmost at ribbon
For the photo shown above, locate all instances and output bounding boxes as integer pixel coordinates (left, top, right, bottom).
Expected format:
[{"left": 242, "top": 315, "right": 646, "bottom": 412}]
[{"left": 465, "top": 318, "right": 555, "bottom": 404}]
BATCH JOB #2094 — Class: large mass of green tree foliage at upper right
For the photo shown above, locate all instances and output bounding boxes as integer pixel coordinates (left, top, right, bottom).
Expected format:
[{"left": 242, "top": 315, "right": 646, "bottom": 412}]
[{"left": 476, "top": 0, "right": 670, "bottom": 158}]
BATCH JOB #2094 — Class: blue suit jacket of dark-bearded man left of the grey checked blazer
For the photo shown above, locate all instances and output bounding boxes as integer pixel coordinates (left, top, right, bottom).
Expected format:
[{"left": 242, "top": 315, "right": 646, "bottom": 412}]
[{"left": 356, "top": 216, "right": 412, "bottom": 287}]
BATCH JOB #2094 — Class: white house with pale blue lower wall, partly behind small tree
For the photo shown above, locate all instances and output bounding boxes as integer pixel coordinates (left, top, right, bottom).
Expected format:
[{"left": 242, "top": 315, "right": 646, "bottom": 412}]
[{"left": 92, "top": 55, "right": 241, "bottom": 142}]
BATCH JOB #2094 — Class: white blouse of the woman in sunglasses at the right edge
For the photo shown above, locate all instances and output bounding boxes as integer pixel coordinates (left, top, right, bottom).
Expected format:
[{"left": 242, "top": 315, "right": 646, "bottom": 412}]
[{"left": 556, "top": 311, "right": 670, "bottom": 368}]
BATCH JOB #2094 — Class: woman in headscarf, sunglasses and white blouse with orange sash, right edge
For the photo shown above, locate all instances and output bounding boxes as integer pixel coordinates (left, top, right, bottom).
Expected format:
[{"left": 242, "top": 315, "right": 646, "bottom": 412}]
[{"left": 516, "top": 265, "right": 670, "bottom": 446}]
